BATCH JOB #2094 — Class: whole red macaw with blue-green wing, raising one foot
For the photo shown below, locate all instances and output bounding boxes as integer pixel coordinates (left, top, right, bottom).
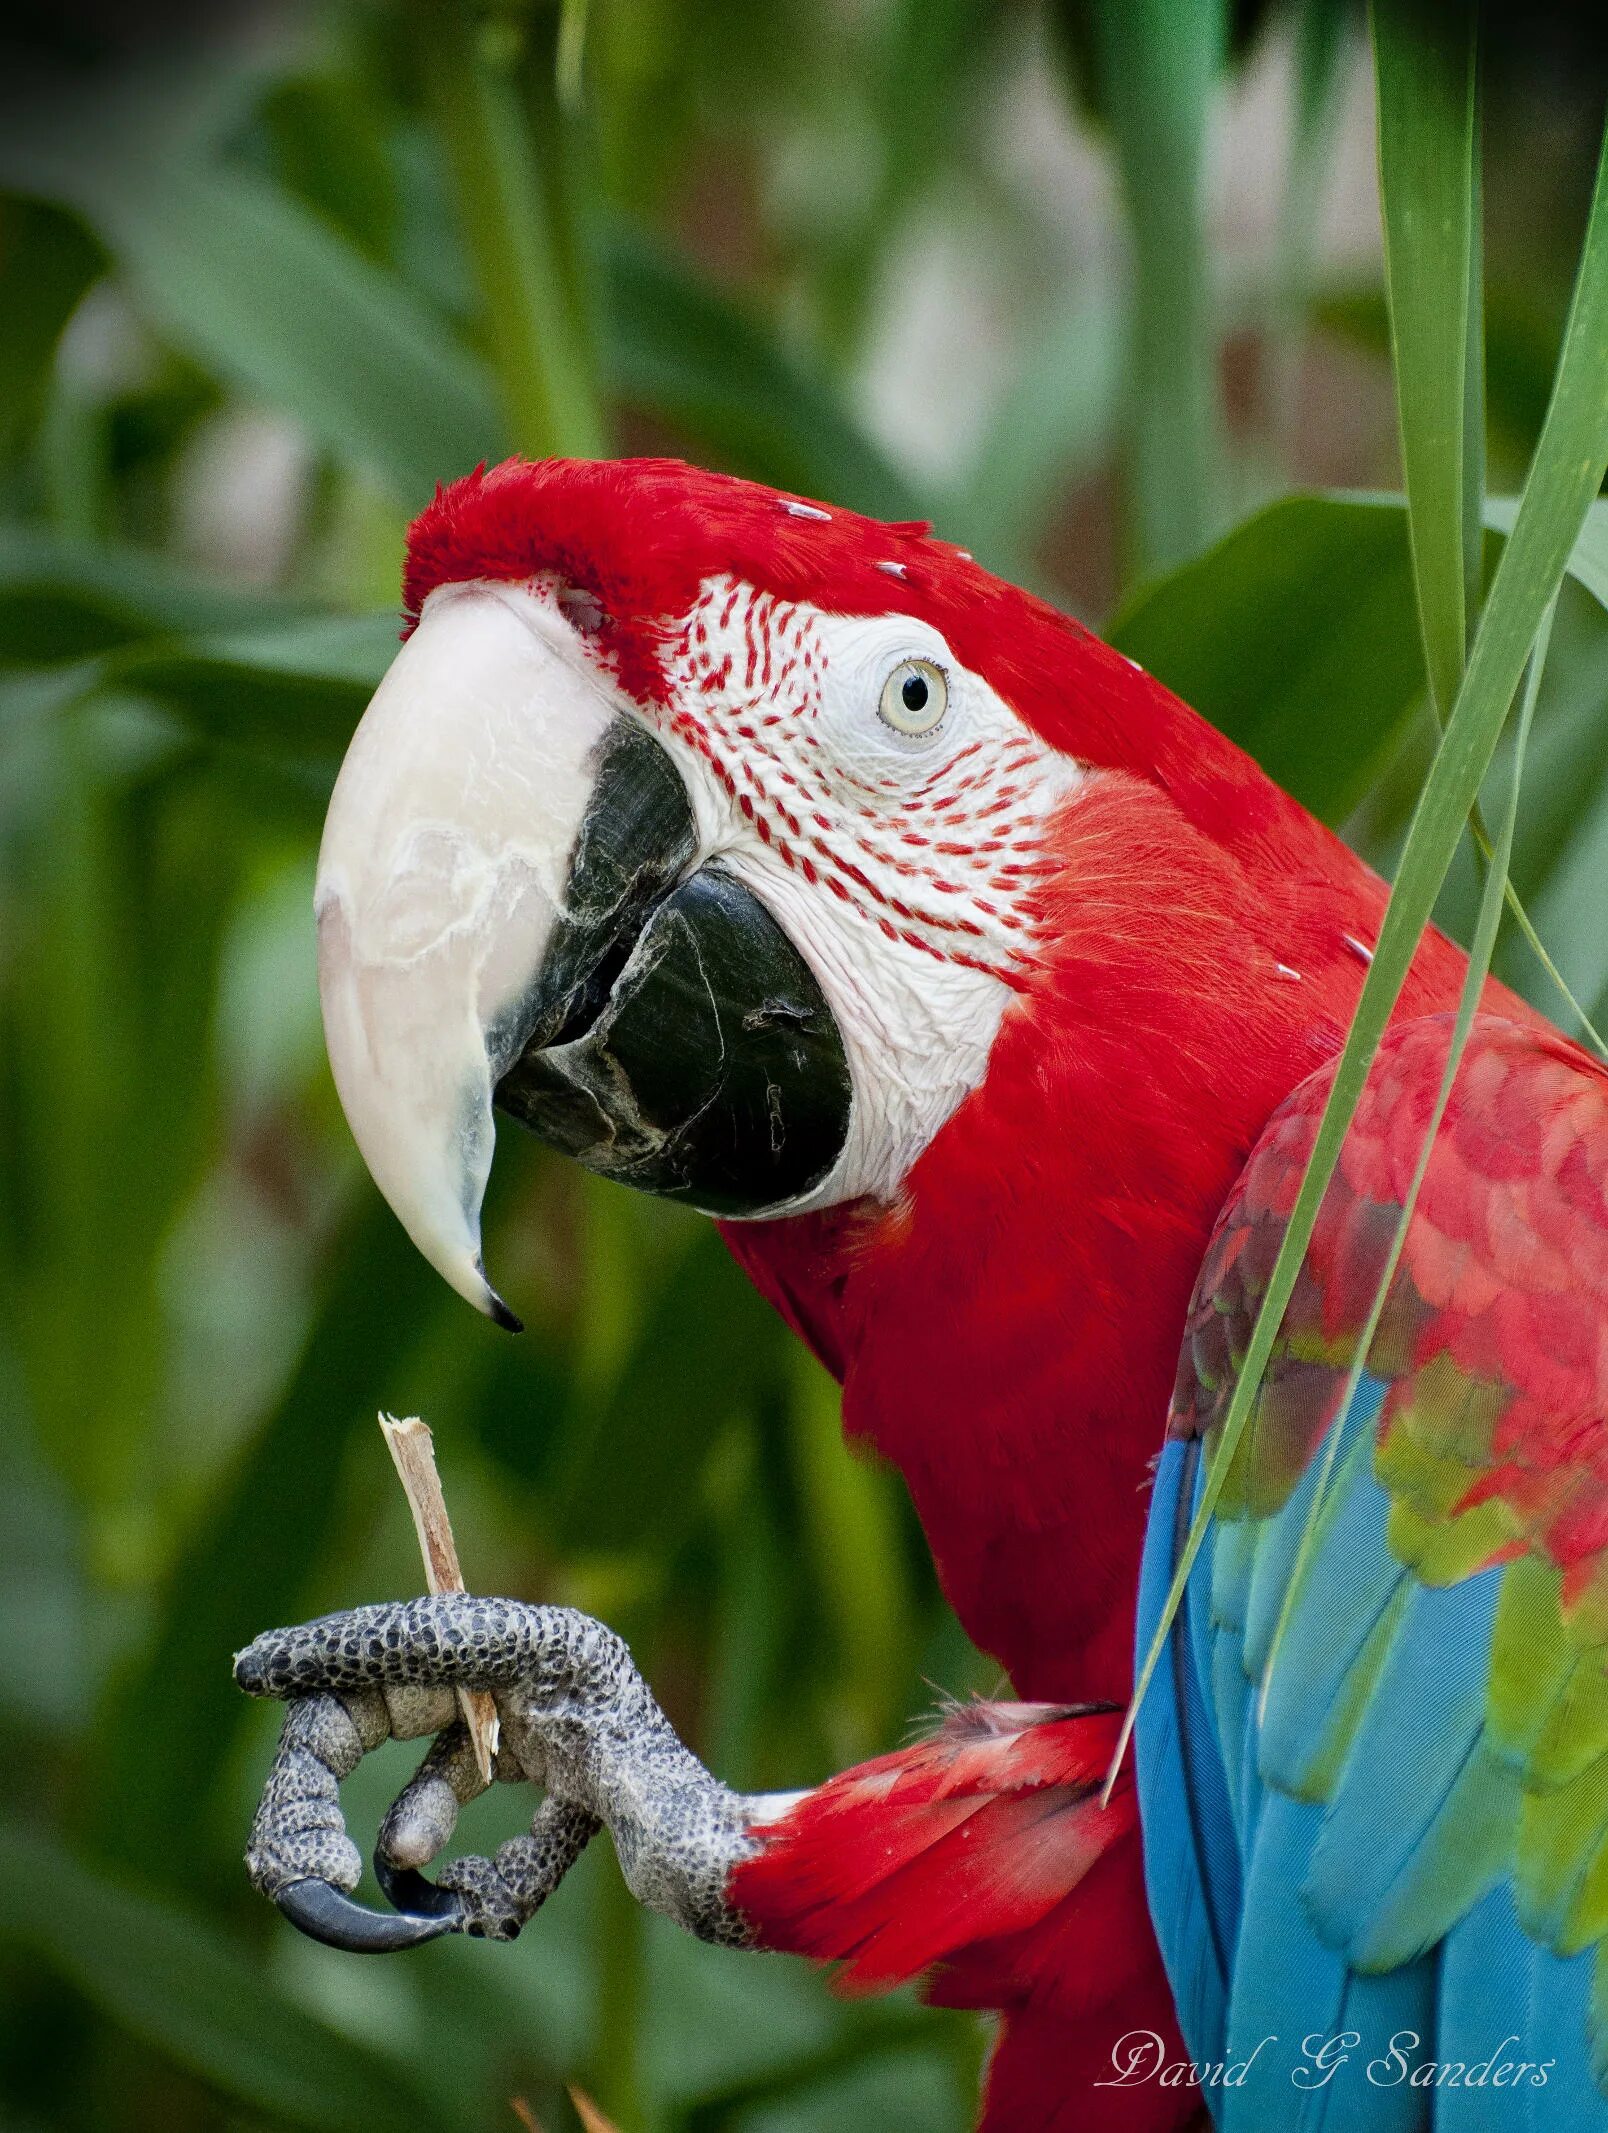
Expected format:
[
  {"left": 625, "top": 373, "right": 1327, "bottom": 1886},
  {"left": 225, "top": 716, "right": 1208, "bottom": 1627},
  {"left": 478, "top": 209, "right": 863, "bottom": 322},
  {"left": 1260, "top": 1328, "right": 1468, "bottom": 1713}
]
[{"left": 237, "top": 461, "right": 1608, "bottom": 2133}]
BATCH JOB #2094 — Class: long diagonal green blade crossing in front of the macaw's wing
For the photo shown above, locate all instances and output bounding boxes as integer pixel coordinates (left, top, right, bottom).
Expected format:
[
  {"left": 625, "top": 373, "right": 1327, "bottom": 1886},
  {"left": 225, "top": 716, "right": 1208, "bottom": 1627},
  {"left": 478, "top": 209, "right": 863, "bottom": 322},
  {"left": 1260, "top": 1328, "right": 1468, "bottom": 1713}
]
[{"left": 1113, "top": 112, "right": 1608, "bottom": 1770}]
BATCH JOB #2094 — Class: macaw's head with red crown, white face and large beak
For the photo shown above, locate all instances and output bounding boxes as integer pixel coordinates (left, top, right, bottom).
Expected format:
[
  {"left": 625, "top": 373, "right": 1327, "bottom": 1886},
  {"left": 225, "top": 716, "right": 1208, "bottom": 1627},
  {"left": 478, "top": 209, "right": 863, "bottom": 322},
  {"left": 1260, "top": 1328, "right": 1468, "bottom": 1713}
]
[{"left": 318, "top": 461, "right": 1297, "bottom": 1318}]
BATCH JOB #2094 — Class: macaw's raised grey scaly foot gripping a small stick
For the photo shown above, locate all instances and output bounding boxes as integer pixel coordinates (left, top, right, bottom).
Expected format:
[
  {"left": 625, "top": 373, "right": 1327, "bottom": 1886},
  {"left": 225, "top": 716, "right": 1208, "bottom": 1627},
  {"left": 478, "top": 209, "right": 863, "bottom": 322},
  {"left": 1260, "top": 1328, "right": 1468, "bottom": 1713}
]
[{"left": 235, "top": 1593, "right": 761, "bottom": 1950}]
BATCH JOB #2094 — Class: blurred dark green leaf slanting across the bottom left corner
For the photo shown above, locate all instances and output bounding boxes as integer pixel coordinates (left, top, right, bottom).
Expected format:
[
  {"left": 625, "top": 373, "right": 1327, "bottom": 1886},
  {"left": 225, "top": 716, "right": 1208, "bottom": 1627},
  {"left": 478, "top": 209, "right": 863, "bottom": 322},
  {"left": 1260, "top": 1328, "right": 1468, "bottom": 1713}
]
[{"left": 0, "top": 1802, "right": 448, "bottom": 2133}]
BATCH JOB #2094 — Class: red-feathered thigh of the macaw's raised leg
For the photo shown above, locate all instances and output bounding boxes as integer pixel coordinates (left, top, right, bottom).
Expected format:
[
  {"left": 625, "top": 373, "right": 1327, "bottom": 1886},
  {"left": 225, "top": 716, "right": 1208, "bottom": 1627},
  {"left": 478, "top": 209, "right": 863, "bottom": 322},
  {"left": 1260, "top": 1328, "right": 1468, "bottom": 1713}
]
[{"left": 731, "top": 1704, "right": 1199, "bottom": 2133}]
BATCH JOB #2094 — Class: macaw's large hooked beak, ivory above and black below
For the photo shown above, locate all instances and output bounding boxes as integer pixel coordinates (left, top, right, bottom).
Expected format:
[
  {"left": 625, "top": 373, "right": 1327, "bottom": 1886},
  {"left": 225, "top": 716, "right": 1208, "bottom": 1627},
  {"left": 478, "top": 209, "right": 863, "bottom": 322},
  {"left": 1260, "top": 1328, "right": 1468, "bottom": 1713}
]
[{"left": 316, "top": 582, "right": 849, "bottom": 1327}]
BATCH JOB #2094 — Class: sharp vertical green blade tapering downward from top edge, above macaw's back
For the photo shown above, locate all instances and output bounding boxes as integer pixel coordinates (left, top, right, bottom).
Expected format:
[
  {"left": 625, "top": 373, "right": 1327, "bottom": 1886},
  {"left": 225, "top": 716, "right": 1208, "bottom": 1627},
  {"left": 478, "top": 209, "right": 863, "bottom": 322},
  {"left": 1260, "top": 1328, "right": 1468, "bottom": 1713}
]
[{"left": 1373, "top": 4, "right": 1482, "bottom": 725}]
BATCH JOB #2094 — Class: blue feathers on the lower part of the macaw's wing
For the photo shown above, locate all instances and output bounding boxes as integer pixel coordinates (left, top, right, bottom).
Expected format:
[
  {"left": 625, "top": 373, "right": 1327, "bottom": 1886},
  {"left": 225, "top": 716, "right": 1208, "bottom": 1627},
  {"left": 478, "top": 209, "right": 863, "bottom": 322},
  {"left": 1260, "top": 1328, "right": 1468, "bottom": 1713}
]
[{"left": 1135, "top": 1416, "right": 1608, "bottom": 2133}]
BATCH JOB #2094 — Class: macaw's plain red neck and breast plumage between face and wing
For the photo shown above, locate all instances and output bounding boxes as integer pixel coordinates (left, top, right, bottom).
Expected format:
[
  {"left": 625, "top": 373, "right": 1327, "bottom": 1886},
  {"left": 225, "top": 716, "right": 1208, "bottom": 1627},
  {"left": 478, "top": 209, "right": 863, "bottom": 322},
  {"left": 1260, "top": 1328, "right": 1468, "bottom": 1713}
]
[{"left": 725, "top": 772, "right": 1501, "bottom": 1700}]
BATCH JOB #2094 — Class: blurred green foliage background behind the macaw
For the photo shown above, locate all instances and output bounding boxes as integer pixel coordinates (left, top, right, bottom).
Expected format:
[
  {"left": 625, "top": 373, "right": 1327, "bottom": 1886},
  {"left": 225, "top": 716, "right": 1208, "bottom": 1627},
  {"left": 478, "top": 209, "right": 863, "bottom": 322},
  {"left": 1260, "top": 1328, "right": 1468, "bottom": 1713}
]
[{"left": 0, "top": 0, "right": 1608, "bottom": 2133}]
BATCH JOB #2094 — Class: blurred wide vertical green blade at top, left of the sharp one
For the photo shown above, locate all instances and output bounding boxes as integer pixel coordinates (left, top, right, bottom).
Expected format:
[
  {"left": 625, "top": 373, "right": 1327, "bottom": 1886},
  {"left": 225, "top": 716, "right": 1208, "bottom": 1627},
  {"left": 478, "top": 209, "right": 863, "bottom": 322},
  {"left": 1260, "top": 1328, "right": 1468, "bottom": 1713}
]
[{"left": 1094, "top": 0, "right": 1226, "bottom": 578}]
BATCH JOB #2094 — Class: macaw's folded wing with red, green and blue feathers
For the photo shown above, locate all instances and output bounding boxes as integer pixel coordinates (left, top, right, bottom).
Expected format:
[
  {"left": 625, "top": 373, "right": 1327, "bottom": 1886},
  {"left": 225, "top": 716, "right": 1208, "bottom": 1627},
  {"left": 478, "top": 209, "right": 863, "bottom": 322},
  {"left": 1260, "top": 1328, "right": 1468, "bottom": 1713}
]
[{"left": 1137, "top": 1017, "right": 1608, "bottom": 2133}]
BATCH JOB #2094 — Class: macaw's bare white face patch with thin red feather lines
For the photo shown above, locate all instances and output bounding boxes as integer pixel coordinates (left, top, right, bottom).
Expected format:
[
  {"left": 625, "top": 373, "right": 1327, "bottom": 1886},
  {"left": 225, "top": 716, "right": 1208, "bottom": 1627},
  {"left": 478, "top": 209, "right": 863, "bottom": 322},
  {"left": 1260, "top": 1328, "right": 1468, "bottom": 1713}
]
[{"left": 635, "top": 580, "right": 1083, "bottom": 1214}]
